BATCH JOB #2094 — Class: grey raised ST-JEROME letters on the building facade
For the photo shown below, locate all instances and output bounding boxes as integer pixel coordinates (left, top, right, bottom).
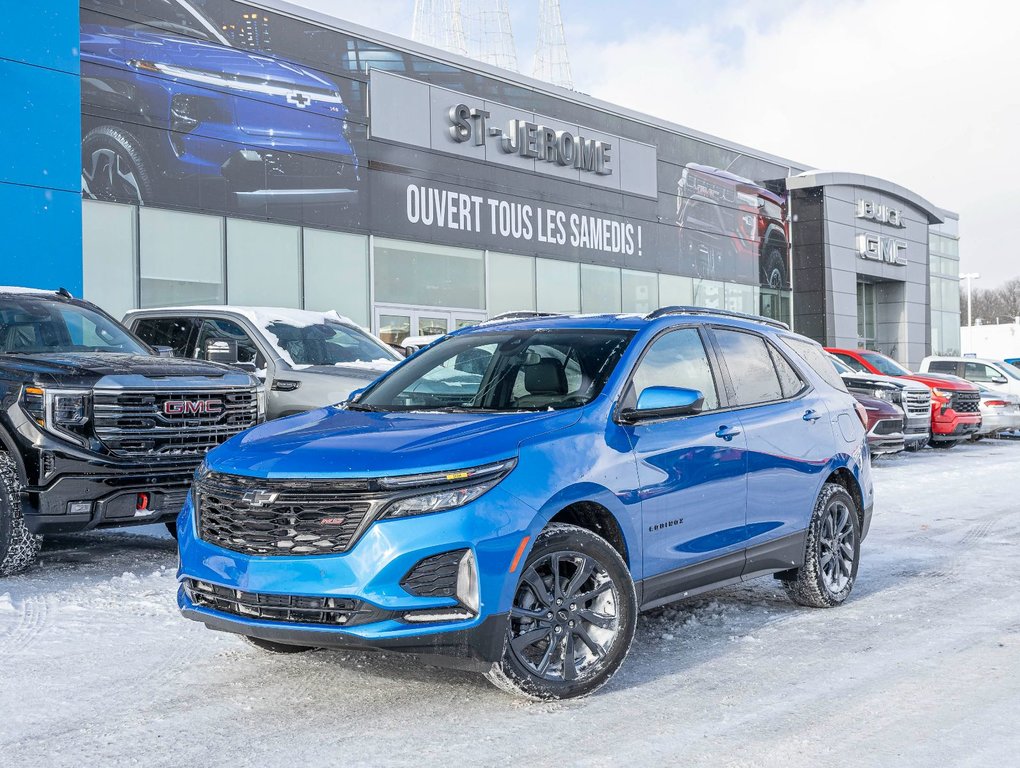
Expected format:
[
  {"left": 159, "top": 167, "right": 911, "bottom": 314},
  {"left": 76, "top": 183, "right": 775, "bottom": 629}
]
[{"left": 449, "top": 104, "right": 613, "bottom": 176}]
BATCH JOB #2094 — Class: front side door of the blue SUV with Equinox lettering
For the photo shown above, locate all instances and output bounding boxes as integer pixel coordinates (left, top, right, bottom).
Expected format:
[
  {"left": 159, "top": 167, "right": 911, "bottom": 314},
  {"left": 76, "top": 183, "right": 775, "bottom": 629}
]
[{"left": 623, "top": 327, "right": 747, "bottom": 604}]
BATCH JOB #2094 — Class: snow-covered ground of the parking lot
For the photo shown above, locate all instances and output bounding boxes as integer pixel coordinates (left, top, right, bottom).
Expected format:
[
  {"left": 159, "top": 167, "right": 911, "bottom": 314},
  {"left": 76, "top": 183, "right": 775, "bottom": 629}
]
[{"left": 0, "top": 442, "right": 1020, "bottom": 768}]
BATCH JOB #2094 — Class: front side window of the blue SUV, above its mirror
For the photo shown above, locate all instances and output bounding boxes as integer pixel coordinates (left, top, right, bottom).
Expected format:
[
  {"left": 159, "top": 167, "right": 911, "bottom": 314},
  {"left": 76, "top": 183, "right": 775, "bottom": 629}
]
[{"left": 633, "top": 328, "right": 719, "bottom": 411}]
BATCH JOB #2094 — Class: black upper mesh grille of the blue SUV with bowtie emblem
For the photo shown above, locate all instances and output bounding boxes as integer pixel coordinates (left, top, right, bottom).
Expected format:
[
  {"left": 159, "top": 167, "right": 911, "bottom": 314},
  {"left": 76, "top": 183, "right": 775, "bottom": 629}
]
[{"left": 195, "top": 473, "right": 389, "bottom": 555}]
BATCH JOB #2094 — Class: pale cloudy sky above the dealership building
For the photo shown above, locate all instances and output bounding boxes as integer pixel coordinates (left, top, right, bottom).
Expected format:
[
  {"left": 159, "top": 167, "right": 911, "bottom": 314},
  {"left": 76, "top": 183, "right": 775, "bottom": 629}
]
[{"left": 292, "top": 0, "right": 1020, "bottom": 288}]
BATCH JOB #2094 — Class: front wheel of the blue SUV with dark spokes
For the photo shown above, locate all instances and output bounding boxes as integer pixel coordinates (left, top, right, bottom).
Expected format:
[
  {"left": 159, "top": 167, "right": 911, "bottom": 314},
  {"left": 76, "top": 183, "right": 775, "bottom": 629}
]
[{"left": 487, "top": 524, "right": 638, "bottom": 700}]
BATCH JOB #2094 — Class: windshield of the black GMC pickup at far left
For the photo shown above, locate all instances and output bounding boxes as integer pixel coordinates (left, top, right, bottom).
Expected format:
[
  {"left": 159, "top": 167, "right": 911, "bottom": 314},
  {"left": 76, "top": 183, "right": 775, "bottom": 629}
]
[{"left": 0, "top": 296, "right": 152, "bottom": 355}]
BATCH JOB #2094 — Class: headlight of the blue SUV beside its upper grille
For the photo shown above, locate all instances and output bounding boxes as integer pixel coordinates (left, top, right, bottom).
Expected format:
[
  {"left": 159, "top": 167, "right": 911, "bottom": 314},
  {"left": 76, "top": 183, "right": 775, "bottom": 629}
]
[{"left": 379, "top": 459, "right": 517, "bottom": 518}]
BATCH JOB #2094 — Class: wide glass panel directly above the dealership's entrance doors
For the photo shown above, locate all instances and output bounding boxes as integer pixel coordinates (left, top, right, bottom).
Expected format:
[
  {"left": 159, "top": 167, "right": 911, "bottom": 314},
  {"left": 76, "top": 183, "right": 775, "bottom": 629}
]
[{"left": 374, "top": 240, "right": 486, "bottom": 309}]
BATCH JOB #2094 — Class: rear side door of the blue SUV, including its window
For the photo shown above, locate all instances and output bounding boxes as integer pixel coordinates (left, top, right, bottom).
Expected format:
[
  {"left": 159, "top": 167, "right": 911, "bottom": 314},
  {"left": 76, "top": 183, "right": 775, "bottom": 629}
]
[{"left": 712, "top": 327, "right": 833, "bottom": 575}]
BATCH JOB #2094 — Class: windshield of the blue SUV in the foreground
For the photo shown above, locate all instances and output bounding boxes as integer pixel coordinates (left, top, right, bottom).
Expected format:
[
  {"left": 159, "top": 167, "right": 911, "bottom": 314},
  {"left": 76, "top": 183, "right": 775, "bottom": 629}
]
[{"left": 349, "top": 329, "right": 633, "bottom": 411}]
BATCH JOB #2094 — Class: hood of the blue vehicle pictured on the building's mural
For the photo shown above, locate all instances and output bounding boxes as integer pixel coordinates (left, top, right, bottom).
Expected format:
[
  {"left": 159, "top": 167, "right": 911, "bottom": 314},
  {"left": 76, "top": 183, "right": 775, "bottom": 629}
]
[{"left": 82, "top": 24, "right": 346, "bottom": 115}]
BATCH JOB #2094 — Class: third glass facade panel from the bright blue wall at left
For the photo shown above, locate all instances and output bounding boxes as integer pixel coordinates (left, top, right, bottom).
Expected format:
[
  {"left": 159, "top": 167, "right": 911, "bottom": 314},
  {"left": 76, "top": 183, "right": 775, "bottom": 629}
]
[{"left": 226, "top": 218, "right": 301, "bottom": 307}]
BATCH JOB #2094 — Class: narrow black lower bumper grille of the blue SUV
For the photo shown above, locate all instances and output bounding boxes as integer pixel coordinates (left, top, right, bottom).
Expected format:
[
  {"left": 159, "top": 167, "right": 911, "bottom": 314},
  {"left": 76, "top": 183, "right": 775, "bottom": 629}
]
[{"left": 184, "top": 578, "right": 388, "bottom": 626}]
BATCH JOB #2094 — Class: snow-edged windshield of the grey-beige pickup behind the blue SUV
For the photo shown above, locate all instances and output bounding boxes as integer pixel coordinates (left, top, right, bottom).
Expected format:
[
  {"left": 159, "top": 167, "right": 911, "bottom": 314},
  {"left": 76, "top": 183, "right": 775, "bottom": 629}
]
[{"left": 265, "top": 320, "right": 400, "bottom": 365}]
